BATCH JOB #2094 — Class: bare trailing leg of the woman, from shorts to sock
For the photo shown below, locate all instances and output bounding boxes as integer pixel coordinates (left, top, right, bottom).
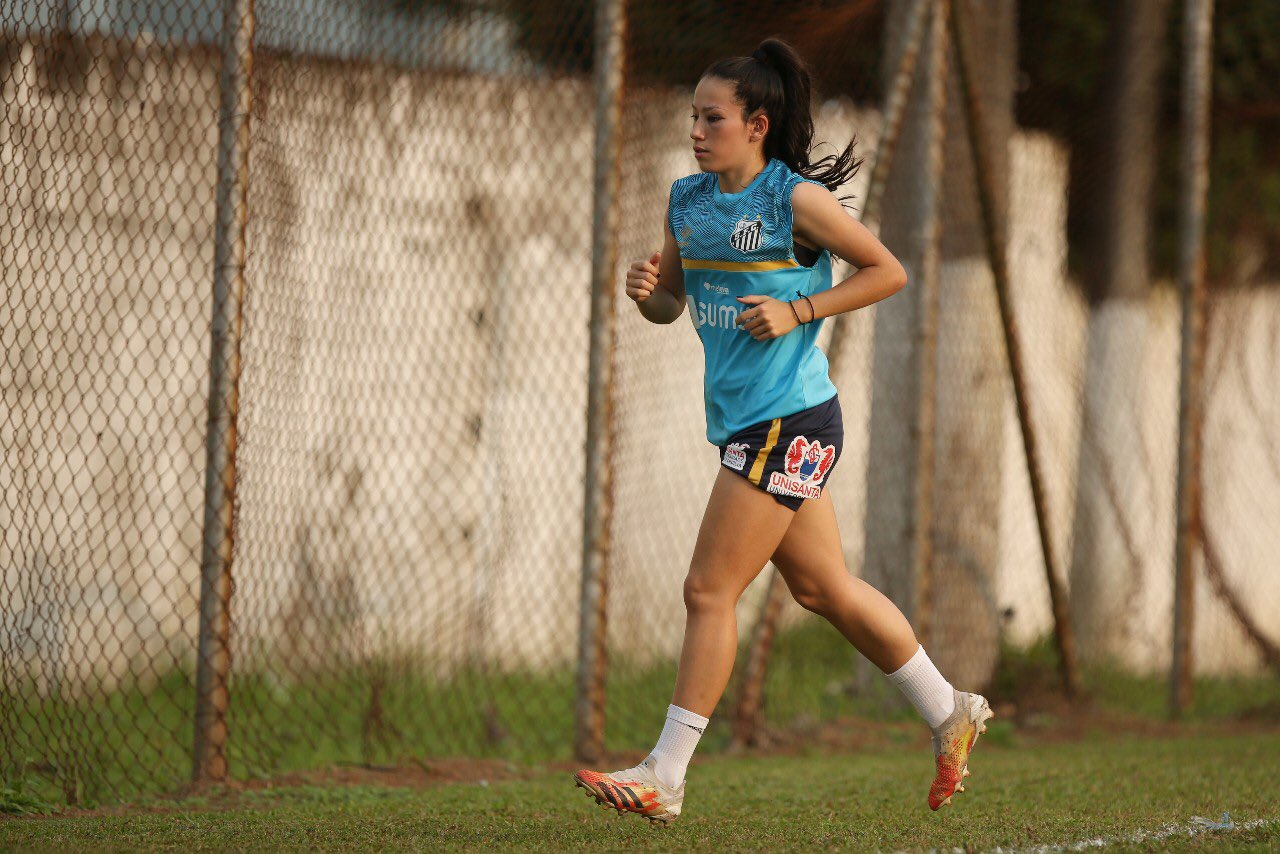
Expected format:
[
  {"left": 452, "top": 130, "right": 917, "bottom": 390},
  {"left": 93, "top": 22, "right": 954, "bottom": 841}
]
[{"left": 773, "top": 489, "right": 919, "bottom": 673}]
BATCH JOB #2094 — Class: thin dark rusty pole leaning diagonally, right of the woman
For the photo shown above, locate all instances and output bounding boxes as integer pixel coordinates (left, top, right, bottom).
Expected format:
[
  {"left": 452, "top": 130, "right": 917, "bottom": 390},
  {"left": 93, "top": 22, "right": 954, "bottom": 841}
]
[{"left": 948, "top": 9, "right": 1080, "bottom": 697}]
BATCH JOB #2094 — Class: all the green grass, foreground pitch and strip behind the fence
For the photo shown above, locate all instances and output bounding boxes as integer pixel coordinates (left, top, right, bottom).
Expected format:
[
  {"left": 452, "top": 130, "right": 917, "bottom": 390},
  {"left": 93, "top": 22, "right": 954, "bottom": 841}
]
[{"left": 0, "top": 625, "right": 1280, "bottom": 850}]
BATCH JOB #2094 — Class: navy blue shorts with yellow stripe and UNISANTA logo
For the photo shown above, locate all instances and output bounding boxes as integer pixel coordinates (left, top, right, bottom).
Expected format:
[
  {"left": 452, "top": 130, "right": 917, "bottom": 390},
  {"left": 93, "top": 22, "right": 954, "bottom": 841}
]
[{"left": 721, "top": 396, "right": 845, "bottom": 510}]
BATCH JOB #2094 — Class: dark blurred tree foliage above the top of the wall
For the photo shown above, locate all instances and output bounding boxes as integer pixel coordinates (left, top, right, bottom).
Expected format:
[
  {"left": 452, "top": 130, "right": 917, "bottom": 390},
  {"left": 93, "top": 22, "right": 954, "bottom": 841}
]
[{"left": 394, "top": 0, "right": 1280, "bottom": 283}]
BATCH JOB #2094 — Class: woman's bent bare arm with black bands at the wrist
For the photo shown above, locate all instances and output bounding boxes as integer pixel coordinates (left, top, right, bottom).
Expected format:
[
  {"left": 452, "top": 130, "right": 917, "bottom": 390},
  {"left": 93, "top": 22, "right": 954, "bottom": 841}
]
[{"left": 737, "top": 183, "right": 906, "bottom": 341}]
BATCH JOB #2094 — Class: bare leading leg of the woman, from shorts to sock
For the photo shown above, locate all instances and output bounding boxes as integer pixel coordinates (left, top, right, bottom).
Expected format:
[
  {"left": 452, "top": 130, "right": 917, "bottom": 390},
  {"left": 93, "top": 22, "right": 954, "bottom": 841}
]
[{"left": 671, "top": 467, "right": 796, "bottom": 717}]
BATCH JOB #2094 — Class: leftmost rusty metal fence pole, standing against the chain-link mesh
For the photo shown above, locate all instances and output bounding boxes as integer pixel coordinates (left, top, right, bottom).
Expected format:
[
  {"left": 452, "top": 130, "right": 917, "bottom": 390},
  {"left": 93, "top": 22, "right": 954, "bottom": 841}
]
[{"left": 192, "top": 0, "right": 253, "bottom": 782}]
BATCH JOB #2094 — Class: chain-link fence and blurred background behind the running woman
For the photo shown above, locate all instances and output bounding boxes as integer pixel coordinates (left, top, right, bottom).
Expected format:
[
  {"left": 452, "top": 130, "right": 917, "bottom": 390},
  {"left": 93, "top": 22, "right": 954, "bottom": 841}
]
[{"left": 0, "top": 0, "right": 1280, "bottom": 803}]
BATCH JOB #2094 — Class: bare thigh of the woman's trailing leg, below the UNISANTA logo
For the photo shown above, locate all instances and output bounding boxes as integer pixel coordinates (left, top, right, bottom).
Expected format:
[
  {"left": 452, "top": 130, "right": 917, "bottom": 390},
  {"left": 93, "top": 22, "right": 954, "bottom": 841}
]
[{"left": 772, "top": 489, "right": 849, "bottom": 607}]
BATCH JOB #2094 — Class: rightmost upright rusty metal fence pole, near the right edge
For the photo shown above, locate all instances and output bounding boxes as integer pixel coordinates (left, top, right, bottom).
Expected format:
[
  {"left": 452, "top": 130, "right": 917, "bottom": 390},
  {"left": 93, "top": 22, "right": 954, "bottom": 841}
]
[{"left": 1169, "top": 0, "right": 1213, "bottom": 717}]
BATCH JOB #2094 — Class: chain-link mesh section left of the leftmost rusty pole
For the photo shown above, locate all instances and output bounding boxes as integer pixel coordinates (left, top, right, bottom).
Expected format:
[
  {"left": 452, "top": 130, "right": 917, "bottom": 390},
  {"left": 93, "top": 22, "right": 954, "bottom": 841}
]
[{"left": 0, "top": 3, "right": 218, "bottom": 802}]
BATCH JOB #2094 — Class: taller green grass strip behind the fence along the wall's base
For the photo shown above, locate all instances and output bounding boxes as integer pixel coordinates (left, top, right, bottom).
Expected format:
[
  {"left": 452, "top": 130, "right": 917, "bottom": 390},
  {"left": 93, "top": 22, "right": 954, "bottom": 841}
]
[{"left": 10, "top": 618, "right": 1280, "bottom": 813}]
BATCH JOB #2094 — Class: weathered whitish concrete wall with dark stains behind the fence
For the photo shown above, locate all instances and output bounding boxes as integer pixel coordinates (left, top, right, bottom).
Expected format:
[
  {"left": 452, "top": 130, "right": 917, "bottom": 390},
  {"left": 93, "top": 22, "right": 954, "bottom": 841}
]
[{"left": 0, "top": 40, "right": 1280, "bottom": 689}]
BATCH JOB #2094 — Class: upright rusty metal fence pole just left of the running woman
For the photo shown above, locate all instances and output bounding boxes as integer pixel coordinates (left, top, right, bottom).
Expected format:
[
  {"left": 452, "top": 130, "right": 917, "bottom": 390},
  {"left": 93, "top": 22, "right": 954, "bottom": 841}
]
[{"left": 573, "top": 0, "right": 626, "bottom": 762}]
